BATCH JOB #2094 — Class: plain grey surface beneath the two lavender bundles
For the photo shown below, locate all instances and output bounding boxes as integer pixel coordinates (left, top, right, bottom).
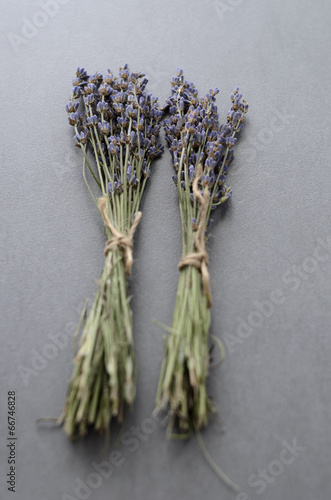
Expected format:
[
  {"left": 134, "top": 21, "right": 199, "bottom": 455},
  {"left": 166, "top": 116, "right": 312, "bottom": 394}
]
[{"left": 0, "top": 0, "right": 331, "bottom": 500}]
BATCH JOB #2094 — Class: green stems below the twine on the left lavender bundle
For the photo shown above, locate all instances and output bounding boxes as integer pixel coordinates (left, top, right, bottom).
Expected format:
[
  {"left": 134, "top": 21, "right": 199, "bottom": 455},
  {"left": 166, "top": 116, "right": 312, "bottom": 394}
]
[{"left": 63, "top": 244, "right": 136, "bottom": 439}]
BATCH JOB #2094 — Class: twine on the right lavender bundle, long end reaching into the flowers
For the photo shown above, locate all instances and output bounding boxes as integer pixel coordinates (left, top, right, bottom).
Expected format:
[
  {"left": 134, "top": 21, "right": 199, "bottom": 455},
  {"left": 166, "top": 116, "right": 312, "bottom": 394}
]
[{"left": 178, "top": 163, "right": 213, "bottom": 307}]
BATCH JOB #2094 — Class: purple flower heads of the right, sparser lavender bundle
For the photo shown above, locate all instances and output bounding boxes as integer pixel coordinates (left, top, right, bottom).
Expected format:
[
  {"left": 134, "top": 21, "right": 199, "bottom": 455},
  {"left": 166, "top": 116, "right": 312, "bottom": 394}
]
[{"left": 164, "top": 69, "right": 248, "bottom": 213}]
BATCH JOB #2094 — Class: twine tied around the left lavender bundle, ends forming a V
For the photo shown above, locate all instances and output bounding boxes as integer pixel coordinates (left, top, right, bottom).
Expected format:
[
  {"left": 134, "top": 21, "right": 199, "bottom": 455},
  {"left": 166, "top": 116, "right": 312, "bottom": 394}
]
[{"left": 98, "top": 197, "right": 142, "bottom": 276}]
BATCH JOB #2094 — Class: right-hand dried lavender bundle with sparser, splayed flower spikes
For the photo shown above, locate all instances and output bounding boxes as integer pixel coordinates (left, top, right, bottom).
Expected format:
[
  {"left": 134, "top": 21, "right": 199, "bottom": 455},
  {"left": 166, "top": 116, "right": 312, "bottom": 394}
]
[{"left": 156, "top": 70, "right": 248, "bottom": 435}]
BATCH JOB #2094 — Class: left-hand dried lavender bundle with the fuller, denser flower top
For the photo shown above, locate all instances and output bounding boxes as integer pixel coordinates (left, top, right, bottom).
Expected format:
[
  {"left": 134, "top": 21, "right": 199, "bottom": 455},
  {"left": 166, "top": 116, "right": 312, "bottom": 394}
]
[{"left": 61, "top": 65, "right": 163, "bottom": 438}]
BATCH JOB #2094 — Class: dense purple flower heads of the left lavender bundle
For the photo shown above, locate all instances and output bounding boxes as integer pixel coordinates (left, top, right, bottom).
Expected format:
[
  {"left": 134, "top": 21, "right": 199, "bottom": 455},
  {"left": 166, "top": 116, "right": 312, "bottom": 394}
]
[{"left": 66, "top": 64, "right": 164, "bottom": 211}]
